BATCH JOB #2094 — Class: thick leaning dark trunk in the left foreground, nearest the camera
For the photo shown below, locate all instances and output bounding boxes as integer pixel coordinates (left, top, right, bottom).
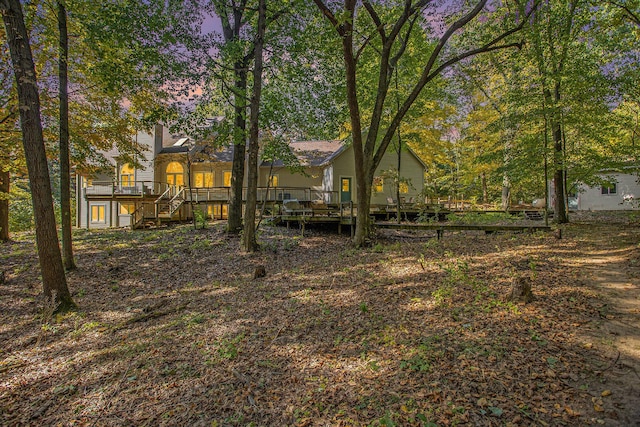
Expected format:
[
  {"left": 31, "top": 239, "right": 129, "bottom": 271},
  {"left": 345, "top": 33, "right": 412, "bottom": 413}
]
[{"left": 0, "top": 0, "right": 75, "bottom": 311}]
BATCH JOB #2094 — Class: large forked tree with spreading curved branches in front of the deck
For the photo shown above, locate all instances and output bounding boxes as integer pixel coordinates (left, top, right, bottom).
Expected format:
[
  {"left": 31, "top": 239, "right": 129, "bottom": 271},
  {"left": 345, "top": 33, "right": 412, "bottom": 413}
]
[{"left": 314, "top": 0, "right": 533, "bottom": 246}]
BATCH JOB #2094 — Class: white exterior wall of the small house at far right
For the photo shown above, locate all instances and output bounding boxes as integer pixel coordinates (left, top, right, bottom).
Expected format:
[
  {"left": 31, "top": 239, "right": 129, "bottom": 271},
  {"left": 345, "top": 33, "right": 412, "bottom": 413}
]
[{"left": 578, "top": 173, "right": 640, "bottom": 211}]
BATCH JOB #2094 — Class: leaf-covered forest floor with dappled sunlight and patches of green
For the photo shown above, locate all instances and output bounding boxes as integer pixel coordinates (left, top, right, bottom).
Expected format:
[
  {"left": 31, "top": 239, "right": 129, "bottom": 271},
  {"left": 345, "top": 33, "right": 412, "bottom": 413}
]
[{"left": 0, "top": 213, "right": 640, "bottom": 426}]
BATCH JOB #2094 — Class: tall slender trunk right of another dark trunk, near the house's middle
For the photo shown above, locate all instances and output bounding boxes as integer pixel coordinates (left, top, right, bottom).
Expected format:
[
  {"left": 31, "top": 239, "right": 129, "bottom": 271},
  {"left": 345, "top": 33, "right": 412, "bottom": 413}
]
[{"left": 242, "top": 0, "right": 267, "bottom": 252}]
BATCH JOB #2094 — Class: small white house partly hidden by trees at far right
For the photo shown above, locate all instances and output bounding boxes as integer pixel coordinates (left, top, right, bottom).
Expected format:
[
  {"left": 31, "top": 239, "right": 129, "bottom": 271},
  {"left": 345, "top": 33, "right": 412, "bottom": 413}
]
[{"left": 576, "top": 172, "right": 640, "bottom": 211}]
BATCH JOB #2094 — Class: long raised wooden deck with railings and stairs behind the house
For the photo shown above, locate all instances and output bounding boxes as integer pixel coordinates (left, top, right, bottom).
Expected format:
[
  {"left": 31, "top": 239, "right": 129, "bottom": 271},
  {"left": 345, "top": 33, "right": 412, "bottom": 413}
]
[{"left": 84, "top": 181, "right": 550, "bottom": 234}]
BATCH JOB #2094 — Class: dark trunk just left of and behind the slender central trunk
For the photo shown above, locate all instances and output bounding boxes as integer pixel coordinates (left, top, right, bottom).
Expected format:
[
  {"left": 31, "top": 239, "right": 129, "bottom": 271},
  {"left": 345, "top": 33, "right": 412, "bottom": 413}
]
[{"left": 227, "top": 70, "right": 247, "bottom": 233}]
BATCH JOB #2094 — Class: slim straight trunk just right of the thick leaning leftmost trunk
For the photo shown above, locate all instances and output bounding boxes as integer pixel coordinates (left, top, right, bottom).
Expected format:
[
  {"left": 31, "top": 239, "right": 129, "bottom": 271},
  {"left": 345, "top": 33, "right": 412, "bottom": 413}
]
[{"left": 58, "top": 1, "right": 76, "bottom": 271}]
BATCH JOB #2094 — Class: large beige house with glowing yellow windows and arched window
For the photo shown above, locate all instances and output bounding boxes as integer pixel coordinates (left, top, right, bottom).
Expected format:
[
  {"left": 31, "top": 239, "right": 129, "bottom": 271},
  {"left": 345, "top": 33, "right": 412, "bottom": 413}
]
[{"left": 76, "top": 125, "right": 425, "bottom": 228}]
